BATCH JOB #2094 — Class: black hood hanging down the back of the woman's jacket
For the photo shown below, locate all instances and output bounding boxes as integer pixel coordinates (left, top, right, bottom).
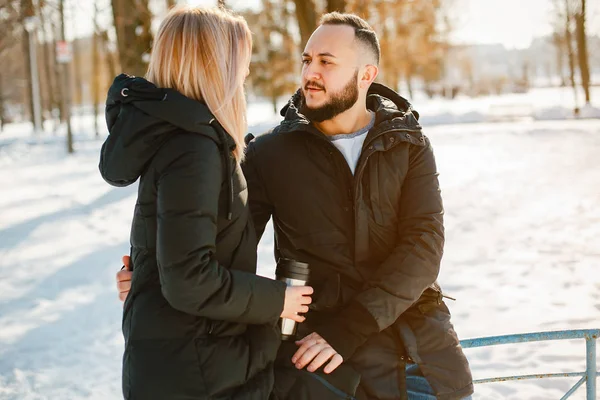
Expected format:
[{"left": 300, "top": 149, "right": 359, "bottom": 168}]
[{"left": 99, "top": 74, "right": 235, "bottom": 186}]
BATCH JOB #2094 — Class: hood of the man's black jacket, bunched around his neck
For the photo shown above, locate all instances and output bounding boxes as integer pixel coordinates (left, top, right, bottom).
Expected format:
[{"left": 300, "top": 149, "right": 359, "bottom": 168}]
[{"left": 280, "top": 83, "right": 421, "bottom": 133}]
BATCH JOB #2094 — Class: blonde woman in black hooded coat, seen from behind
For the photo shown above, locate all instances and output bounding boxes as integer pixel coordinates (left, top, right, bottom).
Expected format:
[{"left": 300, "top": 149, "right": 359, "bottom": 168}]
[{"left": 100, "top": 7, "right": 312, "bottom": 400}]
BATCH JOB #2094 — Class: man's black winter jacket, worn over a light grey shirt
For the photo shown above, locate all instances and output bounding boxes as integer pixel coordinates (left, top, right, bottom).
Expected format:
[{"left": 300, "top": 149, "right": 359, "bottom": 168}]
[{"left": 243, "top": 84, "right": 473, "bottom": 399}]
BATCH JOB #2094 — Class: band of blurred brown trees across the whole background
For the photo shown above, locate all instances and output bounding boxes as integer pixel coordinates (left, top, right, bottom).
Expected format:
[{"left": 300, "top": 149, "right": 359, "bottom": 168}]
[{"left": 0, "top": 0, "right": 600, "bottom": 145}]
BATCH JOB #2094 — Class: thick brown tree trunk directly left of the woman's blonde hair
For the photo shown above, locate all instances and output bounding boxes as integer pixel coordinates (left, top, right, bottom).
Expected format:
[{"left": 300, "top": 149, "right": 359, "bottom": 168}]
[{"left": 111, "top": 0, "right": 152, "bottom": 76}]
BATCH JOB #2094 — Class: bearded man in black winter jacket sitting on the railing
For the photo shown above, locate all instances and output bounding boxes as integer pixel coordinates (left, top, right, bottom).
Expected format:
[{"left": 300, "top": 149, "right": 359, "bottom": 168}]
[{"left": 121, "top": 13, "right": 473, "bottom": 399}]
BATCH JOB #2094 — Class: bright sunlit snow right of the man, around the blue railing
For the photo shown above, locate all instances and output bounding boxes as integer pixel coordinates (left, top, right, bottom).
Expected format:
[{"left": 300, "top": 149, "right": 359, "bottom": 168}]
[{"left": 428, "top": 120, "right": 600, "bottom": 399}]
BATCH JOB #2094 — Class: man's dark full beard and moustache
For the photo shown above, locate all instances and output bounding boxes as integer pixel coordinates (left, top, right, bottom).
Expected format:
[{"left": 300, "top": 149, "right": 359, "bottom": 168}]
[{"left": 299, "top": 69, "right": 358, "bottom": 122}]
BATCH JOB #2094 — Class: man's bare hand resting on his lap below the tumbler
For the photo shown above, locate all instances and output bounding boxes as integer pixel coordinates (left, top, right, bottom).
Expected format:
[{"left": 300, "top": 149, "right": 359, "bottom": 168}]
[{"left": 292, "top": 332, "right": 344, "bottom": 374}]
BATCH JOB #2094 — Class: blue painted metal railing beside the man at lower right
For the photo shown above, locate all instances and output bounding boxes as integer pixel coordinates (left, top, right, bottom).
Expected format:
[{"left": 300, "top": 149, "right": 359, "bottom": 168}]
[{"left": 460, "top": 329, "right": 600, "bottom": 400}]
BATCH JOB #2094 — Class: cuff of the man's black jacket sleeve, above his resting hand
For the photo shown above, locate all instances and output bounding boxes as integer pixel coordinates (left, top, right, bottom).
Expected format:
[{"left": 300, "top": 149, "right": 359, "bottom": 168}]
[{"left": 315, "top": 301, "right": 379, "bottom": 361}]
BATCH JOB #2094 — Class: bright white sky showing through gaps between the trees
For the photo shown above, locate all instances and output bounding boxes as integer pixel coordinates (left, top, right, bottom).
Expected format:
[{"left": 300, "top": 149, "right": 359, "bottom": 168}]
[{"left": 69, "top": 0, "right": 600, "bottom": 48}]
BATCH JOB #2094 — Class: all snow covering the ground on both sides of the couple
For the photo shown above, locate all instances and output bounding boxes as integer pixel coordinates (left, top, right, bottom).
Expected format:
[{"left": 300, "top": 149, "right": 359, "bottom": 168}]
[{"left": 0, "top": 89, "right": 600, "bottom": 400}]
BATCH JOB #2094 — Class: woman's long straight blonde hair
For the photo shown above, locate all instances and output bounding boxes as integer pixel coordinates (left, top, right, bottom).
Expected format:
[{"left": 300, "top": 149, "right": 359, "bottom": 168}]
[{"left": 146, "top": 6, "right": 252, "bottom": 161}]
